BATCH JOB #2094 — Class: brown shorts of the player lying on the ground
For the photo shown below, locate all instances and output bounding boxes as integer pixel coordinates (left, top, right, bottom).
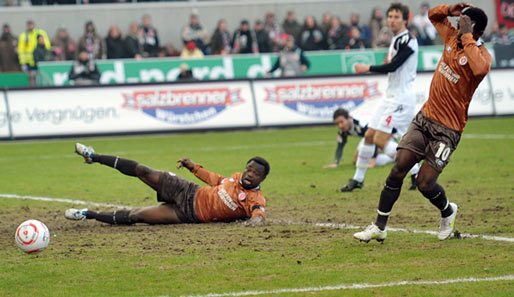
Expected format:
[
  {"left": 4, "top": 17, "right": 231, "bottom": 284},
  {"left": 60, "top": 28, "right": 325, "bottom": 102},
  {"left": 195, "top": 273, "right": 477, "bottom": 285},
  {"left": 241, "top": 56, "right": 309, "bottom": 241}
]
[{"left": 157, "top": 172, "right": 200, "bottom": 223}]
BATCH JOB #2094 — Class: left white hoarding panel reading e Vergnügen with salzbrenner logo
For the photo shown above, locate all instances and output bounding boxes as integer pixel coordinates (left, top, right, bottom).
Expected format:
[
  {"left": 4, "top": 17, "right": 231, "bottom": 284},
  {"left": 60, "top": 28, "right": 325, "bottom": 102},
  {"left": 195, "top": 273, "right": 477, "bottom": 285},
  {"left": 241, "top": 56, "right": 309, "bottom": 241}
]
[{"left": 9, "top": 81, "right": 256, "bottom": 137}]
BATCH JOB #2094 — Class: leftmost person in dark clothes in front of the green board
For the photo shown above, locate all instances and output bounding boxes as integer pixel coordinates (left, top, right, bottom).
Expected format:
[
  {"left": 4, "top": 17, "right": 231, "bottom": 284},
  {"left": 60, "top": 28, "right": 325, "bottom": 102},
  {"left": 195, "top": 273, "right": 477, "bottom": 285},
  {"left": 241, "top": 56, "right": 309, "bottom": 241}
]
[{"left": 68, "top": 49, "right": 100, "bottom": 86}]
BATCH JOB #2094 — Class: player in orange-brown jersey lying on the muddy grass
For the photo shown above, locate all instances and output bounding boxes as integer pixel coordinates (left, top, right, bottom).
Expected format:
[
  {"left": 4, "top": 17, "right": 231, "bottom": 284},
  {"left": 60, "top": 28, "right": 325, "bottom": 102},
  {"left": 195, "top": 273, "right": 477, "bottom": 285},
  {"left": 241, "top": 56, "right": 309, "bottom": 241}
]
[{"left": 64, "top": 143, "right": 270, "bottom": 225}]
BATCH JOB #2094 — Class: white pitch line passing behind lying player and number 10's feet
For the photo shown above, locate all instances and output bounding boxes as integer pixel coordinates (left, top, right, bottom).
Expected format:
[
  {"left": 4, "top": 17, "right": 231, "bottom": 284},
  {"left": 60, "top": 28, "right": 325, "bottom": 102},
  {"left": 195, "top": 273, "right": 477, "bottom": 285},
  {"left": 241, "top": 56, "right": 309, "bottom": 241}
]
[{"left": 0, "top": 193, "right": 514, "bottom": 242}]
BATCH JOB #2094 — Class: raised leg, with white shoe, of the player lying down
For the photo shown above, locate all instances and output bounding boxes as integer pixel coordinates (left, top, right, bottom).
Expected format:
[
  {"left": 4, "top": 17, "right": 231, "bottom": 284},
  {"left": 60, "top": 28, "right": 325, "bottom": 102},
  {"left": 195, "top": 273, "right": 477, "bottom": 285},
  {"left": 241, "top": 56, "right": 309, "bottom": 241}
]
[{"left": 75, "top": 143, "right": 163, "bottom": 190}]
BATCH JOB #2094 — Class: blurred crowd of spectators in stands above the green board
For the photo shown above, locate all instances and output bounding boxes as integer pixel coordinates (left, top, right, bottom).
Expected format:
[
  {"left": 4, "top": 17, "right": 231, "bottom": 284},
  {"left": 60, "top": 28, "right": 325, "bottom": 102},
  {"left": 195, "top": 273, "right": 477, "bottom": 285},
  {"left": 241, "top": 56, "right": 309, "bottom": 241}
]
[{"left": 0, "top": 3, "right": 514, "bottom": 72}]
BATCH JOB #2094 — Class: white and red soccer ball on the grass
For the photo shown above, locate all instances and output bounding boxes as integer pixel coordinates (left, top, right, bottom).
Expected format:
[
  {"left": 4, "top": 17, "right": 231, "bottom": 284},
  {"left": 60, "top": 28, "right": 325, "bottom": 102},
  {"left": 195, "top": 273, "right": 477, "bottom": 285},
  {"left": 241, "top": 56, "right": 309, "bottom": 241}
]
[{"left": 14, "top": 220, "right": 50, "bottom": 254}]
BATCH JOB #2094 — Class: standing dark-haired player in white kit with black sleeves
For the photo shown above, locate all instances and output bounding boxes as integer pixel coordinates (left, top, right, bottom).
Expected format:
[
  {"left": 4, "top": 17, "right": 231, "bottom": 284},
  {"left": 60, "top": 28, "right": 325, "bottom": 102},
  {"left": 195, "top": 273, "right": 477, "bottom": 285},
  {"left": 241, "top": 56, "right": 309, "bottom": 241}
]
[{"left": 341, "top": 3, "right": 419, "bottom": 192}]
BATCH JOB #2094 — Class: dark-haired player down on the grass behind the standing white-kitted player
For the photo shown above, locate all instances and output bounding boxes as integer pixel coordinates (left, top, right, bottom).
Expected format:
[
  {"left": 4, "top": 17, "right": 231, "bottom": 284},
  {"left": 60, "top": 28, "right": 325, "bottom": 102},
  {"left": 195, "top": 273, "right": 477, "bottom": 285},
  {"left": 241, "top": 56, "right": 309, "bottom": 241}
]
[{"left": 323, "top": 108, "right": 417, "bottom": 190}]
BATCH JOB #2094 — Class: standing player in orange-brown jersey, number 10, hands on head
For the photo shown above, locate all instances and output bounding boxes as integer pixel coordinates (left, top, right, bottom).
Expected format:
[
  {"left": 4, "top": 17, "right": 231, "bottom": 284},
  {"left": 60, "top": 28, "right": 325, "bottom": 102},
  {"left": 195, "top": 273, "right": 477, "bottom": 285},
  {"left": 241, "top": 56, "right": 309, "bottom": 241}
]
[{"left": 353, "top": 3, "right": 492, "bottom": 242}]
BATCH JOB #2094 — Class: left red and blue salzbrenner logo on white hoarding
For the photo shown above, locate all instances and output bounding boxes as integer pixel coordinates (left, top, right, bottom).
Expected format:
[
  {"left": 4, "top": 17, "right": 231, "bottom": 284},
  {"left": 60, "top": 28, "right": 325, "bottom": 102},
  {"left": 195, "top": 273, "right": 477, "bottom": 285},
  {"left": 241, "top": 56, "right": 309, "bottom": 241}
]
[{"left": 122, "top": 88, "right": 244, "bottom": 125}]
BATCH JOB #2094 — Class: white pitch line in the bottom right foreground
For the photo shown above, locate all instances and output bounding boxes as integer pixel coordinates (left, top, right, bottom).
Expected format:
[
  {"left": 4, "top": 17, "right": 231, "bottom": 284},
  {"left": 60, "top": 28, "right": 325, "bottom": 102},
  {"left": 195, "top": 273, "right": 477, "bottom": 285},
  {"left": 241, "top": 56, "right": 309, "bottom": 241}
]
[{"left": 173, "top": 274, "right": 514, "bottom": 297}]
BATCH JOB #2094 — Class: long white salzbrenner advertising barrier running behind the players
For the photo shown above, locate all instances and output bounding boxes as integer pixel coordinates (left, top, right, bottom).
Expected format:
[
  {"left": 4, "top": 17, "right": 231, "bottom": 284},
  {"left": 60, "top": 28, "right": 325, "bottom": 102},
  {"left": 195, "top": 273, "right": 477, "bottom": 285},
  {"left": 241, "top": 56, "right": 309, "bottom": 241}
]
[{"left": 0, "top": 68, "right": 514, "bottom": 139}]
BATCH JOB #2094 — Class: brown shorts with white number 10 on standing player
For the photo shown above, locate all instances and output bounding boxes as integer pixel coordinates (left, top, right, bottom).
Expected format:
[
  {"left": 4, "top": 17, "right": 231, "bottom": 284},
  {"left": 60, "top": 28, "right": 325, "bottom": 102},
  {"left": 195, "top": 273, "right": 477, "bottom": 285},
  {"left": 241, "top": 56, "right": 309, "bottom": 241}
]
[{"left": 398, "top": 111, "right": 461, "bottom": 173}]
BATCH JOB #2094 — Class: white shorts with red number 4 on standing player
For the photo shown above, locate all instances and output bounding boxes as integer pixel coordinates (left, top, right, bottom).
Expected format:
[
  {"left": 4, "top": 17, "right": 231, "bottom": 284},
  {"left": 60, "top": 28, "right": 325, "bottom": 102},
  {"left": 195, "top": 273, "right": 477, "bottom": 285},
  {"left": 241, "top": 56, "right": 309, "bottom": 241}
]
[{"left": 368, "top": 100, "right": 415, "bottom": 137}]
